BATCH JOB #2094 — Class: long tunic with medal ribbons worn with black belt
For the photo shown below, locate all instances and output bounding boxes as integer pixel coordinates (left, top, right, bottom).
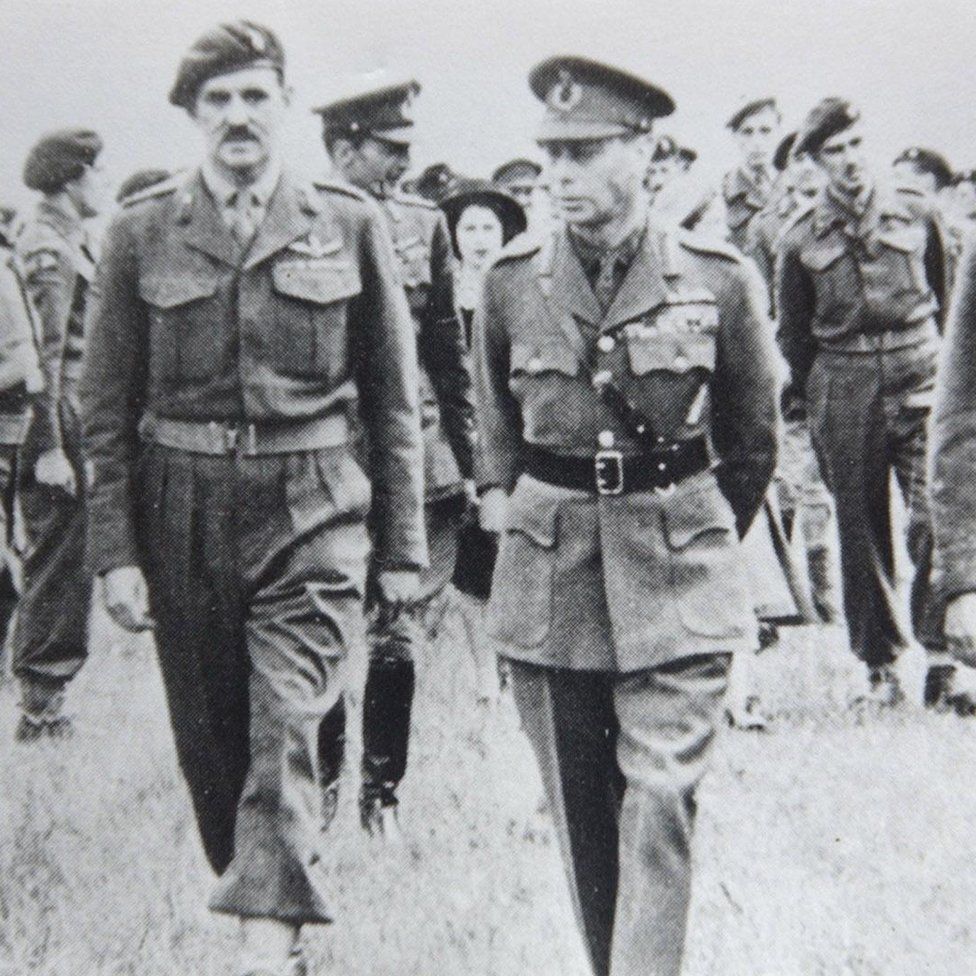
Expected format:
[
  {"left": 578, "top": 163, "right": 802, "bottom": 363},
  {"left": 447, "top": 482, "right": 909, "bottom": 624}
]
[{"left": 475, "top": 219, "right": 777, "bottom": 671}]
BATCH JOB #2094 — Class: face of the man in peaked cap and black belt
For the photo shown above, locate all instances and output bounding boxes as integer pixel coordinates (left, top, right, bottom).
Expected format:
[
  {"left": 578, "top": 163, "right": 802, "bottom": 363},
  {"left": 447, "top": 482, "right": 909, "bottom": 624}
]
[{"left": 543, "top": 137, "right": 651, "bottom": 228}]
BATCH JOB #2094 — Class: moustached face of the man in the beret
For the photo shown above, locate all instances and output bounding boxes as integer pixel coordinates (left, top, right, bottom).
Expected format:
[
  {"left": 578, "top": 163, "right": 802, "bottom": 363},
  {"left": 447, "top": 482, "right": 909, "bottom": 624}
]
[{"left": 192, "top": 68, "right": 289, "bottom": 178}]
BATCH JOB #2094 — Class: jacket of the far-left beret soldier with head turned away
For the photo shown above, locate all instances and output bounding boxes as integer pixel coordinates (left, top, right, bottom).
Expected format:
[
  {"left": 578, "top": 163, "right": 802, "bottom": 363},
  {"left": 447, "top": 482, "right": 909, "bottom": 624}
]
[{"left": 16, "top": 199, "right": 95, "bottom": 461}]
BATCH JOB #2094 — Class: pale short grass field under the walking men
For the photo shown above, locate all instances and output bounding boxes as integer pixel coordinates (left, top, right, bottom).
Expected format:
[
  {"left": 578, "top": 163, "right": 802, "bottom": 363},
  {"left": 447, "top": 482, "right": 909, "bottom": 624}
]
[{"left": 0, "top": 604, "right": 976, "bottom": 976}]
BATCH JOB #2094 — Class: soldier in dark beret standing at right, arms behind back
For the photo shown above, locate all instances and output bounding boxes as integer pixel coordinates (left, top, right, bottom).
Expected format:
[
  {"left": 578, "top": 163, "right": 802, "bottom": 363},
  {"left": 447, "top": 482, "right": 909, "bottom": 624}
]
[{"left": 776, "top": 98, "right": 951, "bottom": 705}]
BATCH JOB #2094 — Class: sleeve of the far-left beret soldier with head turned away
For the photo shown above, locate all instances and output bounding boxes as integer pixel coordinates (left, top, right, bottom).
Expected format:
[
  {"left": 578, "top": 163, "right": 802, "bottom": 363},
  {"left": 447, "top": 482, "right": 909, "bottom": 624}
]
[{"left": 18, "top": 228, "right": 77, "bottom": 460}]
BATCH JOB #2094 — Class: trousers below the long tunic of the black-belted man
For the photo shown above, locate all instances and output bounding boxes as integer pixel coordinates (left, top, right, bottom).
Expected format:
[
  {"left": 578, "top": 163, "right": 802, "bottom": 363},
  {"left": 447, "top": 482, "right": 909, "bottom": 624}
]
[{"left": 509, "top": 654, "right": 731, "bottom": 976}]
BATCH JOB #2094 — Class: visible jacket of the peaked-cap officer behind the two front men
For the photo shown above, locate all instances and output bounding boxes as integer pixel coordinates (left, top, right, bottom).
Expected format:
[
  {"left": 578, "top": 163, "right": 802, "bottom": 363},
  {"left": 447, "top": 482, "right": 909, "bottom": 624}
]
[{"left": 380, "top": 196, "right": 474, "bottom": 500}]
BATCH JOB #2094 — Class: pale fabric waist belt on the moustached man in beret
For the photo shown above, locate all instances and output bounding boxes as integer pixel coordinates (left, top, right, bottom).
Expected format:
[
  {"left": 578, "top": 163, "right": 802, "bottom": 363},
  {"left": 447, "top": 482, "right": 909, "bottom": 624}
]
[{"left": 148, "top": 414, "right": 349, "bottom": 457}]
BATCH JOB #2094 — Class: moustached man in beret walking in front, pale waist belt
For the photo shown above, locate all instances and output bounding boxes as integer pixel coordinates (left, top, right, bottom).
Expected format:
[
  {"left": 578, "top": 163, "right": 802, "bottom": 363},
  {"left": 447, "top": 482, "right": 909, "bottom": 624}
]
[{"left": 81, "top": 21, "right": 427, "bottom": 976}]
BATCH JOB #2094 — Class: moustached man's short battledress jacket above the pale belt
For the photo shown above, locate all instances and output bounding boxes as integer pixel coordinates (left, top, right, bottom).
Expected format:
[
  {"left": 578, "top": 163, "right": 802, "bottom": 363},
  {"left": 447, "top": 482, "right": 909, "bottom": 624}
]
[{"left": 81, "top": 173, "right": 426, "bottom": 572}]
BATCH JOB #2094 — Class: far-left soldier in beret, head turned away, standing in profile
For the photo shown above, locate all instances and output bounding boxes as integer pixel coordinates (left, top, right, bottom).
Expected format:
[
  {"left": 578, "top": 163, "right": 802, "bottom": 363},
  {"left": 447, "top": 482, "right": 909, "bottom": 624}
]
[{"left": 13, "top": 129, "right": 110, "bottom": 742}]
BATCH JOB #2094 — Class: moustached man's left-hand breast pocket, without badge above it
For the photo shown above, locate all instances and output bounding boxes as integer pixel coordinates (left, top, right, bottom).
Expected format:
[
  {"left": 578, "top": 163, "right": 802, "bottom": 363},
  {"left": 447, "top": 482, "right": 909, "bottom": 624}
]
[{"left": 139, "top": 275, "right": 224, "bottom": 380}]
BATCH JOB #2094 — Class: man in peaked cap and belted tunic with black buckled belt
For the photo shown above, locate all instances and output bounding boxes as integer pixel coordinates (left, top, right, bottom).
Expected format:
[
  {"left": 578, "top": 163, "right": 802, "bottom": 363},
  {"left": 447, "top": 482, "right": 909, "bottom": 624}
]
[{"left": 475, "top": 57, "right": 777, "bottom": 976}]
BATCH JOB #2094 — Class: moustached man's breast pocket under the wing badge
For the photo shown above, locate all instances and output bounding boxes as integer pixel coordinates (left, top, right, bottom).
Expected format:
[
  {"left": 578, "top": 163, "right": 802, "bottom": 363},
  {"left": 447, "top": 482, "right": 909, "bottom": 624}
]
[{"left": 269, "top": 261, "right": 362, "bottom": 378}]
